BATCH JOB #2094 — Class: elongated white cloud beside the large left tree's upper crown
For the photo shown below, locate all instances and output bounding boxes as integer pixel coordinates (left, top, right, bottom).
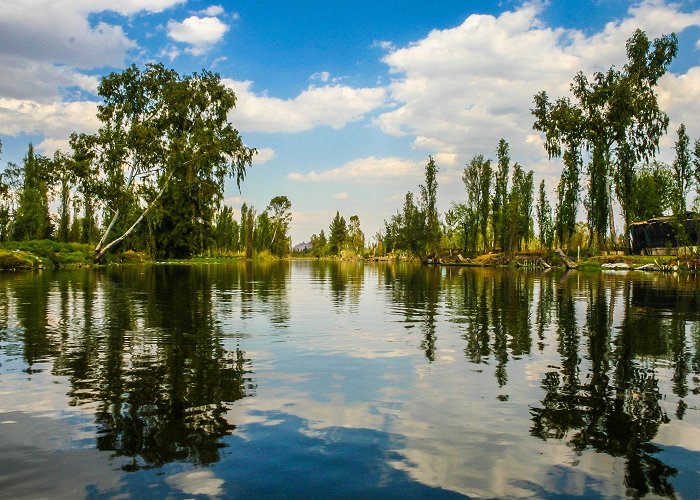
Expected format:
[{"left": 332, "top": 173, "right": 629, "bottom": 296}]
[{"left": 224, "top": 80, "right": 385, "bottom": 132}]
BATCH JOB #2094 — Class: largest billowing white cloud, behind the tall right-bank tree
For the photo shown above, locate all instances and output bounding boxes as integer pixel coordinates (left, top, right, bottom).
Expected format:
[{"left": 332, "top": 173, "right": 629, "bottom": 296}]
[{"left": 374, "top": 1, "right": 700, "bottom": 177}]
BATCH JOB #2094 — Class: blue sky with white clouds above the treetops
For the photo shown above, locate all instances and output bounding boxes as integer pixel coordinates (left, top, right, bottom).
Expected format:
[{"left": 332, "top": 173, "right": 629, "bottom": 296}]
[{"left": 0, "top": 0, "right": 700, "bottom": 244}]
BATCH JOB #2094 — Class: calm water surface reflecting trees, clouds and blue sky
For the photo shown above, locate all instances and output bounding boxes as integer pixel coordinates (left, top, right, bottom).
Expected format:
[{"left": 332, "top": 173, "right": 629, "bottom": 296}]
[{"left": 0, "top": 261, "right": 700, "bottom": 498}]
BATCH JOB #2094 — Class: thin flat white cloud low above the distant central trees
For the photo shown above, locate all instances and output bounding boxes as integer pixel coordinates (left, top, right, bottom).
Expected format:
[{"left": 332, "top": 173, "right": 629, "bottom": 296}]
[{"left": 287, "top": 156, "right": 423, "bottom": 182}]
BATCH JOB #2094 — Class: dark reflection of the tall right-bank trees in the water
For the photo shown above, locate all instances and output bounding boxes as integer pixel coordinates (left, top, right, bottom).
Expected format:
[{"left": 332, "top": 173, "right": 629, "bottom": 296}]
[{"left": 531, "top": 279, "right": 698, "bottom": 496}]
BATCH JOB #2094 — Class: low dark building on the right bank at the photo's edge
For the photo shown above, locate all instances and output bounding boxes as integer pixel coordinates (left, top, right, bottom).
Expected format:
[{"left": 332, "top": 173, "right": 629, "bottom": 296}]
[{"left": 630, "top": 212, "right": 700, "bottom": 255}]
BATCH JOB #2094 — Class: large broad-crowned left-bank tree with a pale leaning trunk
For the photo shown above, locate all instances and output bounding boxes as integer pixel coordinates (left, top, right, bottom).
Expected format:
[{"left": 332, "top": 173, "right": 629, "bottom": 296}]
[{"left": 73, "top": 64, "right": 255, "bottom": 260}]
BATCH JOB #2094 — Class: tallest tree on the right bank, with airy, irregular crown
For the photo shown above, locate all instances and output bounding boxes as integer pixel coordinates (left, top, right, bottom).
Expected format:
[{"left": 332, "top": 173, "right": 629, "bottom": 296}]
[{"left": 532, "top": 30, "right": 678, "bottom": 250}]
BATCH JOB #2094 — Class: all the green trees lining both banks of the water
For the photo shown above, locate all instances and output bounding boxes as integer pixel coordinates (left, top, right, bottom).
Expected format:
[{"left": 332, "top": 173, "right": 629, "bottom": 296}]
[{"left": 0, "top": 30, "right": 700, "bottom": 260}]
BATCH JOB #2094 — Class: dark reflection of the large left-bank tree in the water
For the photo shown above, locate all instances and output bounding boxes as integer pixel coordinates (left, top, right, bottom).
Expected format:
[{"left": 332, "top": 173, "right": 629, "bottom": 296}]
[{"left": 5, "top": 266, "right": 258, "bottom": 470}]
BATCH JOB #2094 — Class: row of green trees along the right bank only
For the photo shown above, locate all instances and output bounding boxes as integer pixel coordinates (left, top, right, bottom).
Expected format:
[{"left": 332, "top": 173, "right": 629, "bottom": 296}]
[{"left": 377, "top": 30, "right": 700, "bottom": 258}]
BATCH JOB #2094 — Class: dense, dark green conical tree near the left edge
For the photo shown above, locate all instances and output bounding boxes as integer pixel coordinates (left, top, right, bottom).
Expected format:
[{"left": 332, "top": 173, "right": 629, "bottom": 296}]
[{"left": 12, "top": 144, "right": 53, "bottom": 240}]
